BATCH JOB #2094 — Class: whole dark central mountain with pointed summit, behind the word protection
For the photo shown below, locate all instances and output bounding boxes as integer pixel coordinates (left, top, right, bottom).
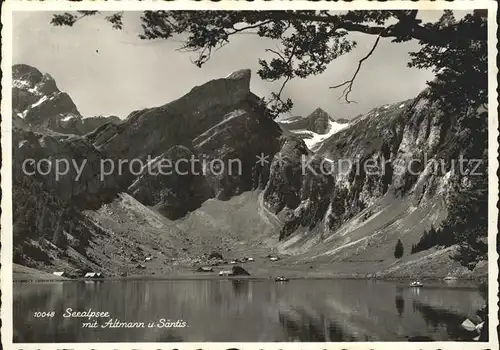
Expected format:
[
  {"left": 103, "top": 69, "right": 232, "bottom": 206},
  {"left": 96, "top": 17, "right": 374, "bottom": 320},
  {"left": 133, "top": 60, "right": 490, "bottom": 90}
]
[{"left": 94, "top": 70, "right": 280, "bottom": 219}]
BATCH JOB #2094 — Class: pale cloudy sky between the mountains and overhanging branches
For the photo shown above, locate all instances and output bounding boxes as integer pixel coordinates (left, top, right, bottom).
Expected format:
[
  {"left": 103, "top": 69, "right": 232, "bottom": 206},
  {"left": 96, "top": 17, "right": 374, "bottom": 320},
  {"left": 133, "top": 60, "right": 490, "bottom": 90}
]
[{"left": 12, "top": 11, "right": 441, "bottom": 119}]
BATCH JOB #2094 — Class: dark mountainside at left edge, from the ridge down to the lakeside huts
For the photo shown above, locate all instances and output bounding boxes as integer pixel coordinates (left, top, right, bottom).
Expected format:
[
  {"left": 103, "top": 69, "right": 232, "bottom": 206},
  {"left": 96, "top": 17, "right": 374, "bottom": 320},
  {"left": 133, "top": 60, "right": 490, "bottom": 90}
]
[{"left": 12, "top": 124, "right": 127, "bottom": 268}]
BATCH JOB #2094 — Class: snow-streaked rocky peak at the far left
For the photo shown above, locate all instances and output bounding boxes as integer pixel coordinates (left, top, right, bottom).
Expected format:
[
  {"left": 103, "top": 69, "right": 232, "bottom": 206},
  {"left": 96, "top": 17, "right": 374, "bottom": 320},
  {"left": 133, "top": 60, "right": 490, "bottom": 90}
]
[{"left": 12, "top": 64, "right": 120, "bottom": 135}]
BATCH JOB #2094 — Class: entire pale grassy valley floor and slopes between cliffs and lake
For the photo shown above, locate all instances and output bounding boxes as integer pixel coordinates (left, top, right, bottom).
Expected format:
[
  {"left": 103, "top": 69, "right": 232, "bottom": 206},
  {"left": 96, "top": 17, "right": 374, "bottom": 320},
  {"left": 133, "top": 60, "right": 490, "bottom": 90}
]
[{"left": 14, "top": 186, "right": 486, "bottom": 279}]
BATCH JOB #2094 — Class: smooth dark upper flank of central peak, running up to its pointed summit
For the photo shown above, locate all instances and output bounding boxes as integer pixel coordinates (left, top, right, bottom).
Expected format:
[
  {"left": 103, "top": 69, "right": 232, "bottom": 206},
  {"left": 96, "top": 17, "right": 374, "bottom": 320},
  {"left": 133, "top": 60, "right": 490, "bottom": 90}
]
[{"left": 91, "top": 70, "right": 260, "bottom": 159}]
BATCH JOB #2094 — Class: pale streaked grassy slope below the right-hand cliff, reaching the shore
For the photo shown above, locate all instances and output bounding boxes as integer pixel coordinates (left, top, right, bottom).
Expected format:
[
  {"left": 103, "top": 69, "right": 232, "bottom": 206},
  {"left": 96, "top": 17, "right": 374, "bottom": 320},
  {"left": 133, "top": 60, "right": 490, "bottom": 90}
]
[{"left": 281, "top": 191, "right": 487, "bottom": 278}]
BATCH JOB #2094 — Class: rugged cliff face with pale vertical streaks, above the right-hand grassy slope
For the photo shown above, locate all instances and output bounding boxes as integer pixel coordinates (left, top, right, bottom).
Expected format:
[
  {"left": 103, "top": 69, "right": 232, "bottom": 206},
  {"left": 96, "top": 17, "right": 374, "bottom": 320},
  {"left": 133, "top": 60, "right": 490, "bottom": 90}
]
[{"left": 264, "top": 92, "right": 458, "bottom": 242}]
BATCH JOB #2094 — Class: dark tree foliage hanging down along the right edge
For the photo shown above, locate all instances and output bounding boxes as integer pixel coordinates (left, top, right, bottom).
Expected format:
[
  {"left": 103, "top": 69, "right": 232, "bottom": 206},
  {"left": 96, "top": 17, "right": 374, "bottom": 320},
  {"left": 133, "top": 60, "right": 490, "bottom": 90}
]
[{"left": 410, "top": 10, "right": 488, "bottom": 269}]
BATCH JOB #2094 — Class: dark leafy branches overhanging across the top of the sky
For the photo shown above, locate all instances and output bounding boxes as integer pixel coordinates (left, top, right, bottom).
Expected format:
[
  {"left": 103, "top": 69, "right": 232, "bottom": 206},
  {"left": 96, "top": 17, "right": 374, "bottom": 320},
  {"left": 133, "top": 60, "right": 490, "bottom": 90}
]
[{"left": 51, "top": 10, "right": 487, "bottom": 115}]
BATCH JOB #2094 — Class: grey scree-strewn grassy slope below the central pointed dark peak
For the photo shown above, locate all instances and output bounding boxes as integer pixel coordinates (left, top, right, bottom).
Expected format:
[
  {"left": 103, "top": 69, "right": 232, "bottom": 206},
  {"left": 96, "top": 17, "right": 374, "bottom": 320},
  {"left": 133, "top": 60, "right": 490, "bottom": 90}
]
[{"left": 38, "top": 192, "right": 279, "bottom": 277}]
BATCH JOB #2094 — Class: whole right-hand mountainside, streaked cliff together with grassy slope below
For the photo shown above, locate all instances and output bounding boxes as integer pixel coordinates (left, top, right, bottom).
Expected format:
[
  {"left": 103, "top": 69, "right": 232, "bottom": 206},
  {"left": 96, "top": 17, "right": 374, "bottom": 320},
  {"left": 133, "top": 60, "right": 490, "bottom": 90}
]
[{"left": 263, "top": 91, "right": 484, "bottom": 275}]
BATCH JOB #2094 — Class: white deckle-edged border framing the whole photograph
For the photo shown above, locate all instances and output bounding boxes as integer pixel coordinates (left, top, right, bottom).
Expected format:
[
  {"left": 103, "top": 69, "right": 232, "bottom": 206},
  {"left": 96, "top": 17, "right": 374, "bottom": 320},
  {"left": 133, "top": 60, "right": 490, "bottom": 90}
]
[{"left": 0, "top": 0, "right": 499, "bottom": 350}]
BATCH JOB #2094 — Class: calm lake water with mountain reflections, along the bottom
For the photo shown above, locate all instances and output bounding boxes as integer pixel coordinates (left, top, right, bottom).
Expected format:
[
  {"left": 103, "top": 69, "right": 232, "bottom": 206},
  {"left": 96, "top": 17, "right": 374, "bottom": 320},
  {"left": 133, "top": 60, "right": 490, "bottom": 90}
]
[{"left": 13, "top": 280, "right": 484, "bottom": 343}]
